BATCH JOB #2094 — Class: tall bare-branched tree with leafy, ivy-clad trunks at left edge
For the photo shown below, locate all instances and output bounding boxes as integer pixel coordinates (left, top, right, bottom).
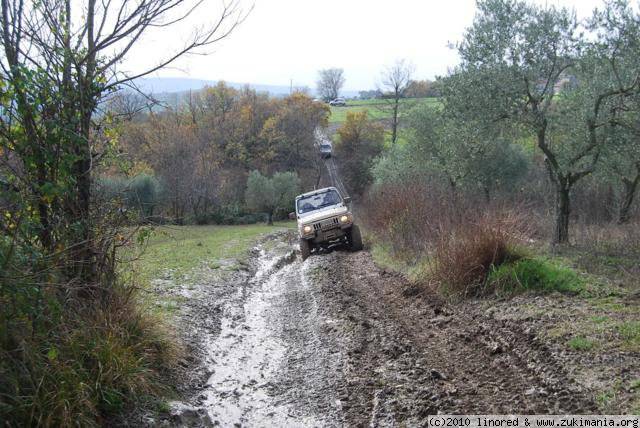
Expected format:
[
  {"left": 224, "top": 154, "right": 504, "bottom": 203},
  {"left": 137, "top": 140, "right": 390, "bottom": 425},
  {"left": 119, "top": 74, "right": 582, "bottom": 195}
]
[{"left": 0, "top": 0, "right": 246, "bottom": 278}]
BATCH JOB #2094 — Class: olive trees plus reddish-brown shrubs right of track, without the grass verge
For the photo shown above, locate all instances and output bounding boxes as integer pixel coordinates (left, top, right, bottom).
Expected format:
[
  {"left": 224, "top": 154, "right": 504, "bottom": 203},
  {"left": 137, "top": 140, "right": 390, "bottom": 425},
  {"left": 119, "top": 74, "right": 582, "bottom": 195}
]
[{"left": 366, "top": 0, "right": 640, "bottom": 293}]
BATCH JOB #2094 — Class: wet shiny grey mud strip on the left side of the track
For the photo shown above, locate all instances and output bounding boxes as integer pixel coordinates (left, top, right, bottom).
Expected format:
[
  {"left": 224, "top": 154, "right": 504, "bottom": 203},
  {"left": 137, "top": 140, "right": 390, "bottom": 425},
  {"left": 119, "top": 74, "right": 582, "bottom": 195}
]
[{"left": 159, "top": 236, "right": 338, "bottom": 427}]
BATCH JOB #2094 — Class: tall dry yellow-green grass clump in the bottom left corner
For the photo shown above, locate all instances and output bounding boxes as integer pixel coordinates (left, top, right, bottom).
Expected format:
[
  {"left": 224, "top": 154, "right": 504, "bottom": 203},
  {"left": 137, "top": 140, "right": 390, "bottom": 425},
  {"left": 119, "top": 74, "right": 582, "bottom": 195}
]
[{"left": 0, "top": 280, "right": 181, "bottom": 427}]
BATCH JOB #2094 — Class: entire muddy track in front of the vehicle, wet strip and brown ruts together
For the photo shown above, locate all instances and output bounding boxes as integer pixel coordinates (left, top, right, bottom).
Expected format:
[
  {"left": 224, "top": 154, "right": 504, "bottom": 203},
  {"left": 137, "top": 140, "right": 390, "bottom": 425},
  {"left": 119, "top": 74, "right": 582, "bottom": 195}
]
[{"left": 141, "top": 233, "right": 596, "bottom": 427}]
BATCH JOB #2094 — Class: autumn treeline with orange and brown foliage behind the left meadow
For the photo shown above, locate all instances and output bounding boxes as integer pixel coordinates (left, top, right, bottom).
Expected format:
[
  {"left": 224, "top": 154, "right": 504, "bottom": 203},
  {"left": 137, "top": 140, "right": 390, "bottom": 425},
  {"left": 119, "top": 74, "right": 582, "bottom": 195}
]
[{"left": 110, "top": 83, "right": 329, "bottom": 224}]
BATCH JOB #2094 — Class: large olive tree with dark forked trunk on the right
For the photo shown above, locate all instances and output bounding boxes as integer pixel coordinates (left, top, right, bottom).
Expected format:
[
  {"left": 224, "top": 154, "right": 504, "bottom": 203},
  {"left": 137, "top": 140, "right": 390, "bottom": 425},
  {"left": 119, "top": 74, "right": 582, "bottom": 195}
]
[{"left": 443, "top": 0, "right": 639, "bottom": 243}]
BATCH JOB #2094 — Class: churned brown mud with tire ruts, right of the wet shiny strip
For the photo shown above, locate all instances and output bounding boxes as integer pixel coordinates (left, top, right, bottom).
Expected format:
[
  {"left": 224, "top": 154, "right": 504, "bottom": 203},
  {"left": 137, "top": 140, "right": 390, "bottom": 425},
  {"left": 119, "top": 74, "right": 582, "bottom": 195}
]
[{"left": 312, "top": 253, "right": 596, "bottom": 426}]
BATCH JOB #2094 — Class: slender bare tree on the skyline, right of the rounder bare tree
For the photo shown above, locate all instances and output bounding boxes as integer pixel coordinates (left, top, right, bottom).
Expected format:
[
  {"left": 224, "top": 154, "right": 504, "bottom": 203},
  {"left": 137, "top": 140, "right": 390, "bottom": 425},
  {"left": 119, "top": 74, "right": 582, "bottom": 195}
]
[{"left": 379, "top": 60, "right": 414, "bottom": 144}]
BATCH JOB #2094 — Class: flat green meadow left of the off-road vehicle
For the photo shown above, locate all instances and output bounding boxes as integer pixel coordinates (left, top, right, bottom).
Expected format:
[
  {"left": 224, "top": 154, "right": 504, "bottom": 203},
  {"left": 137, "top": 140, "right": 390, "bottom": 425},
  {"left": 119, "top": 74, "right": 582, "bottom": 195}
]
[{"left": 135, "top": 222, "right": 294, "bottom": 283}]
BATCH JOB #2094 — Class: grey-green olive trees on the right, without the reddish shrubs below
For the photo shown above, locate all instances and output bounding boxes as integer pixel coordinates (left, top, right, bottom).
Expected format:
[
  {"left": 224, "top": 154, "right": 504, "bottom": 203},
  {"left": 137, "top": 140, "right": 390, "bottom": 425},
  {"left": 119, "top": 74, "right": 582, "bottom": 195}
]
[{"left": 362, "top": 0, "right": 640, "bottom": 243}]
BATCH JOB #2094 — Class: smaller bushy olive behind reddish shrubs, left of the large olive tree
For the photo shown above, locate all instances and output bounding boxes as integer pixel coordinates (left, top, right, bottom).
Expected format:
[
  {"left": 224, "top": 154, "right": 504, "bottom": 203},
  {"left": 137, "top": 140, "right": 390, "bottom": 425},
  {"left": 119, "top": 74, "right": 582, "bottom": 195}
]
[{"left": 374, "top": 105, "right": 528, "bottom": 200}]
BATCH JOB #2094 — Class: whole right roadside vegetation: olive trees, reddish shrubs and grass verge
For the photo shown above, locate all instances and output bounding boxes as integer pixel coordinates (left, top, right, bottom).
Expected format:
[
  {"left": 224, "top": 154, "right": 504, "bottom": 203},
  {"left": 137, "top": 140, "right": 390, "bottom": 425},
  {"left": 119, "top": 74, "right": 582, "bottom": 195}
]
[{"left": 351, "top": 0, "right": 640, "bottom": 413}]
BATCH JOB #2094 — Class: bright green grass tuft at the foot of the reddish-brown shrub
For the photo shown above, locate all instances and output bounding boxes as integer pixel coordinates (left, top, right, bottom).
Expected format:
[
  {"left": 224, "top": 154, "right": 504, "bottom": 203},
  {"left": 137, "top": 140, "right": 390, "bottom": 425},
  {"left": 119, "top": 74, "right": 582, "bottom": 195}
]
[{"left": 487, "top": 258, "right": 586, "bottom": 294}]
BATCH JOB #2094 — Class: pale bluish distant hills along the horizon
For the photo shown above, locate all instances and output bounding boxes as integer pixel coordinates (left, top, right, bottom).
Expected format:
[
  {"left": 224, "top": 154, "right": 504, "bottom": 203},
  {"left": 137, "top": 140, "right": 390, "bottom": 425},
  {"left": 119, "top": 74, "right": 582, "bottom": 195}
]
[{"left": 135, "top": 77, "right": 358, "bottom": 97}]
